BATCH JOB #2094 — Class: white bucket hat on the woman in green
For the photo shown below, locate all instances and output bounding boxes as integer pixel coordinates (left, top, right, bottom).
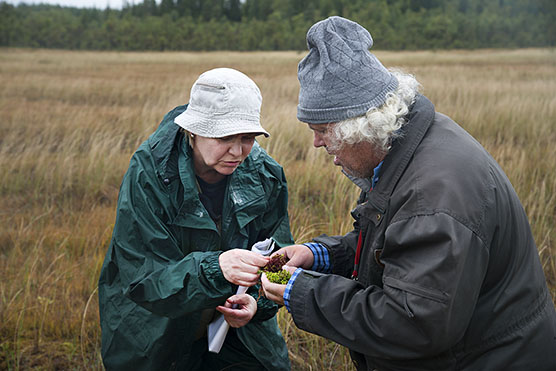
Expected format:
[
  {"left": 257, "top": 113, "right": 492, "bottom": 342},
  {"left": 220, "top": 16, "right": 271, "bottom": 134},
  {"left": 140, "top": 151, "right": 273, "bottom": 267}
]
[{"left": 174, "top": 68, "right": 270, "bottom": 138}]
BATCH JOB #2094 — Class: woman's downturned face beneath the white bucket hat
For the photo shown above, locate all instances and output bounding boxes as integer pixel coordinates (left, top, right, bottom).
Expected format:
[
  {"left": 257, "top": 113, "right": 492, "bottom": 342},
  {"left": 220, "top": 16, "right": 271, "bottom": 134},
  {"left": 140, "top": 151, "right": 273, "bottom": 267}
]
[{"left": 189, "top": 134, "right": 257, "bottom": 183}]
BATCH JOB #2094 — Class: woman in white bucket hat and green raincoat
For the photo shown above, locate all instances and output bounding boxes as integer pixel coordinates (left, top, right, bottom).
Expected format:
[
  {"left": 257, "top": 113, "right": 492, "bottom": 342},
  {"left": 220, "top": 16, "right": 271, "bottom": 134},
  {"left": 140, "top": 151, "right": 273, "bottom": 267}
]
[{"left": 99, "top": 68, "right": 292, "bottom": 370}]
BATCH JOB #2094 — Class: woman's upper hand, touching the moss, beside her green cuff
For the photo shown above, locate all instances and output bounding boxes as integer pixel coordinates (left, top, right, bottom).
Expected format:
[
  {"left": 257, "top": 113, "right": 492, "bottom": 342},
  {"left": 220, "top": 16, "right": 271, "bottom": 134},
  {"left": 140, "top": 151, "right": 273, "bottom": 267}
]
[{"left": 218, "top": 249, "right": 270, "bottom": 287}]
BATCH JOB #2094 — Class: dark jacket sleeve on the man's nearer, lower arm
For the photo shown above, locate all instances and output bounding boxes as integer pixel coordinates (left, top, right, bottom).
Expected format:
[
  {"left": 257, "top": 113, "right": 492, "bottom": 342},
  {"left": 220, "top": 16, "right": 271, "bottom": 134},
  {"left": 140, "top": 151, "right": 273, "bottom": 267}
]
[{"left": 290, "top": 213, "right": 488, "bottom": 359}]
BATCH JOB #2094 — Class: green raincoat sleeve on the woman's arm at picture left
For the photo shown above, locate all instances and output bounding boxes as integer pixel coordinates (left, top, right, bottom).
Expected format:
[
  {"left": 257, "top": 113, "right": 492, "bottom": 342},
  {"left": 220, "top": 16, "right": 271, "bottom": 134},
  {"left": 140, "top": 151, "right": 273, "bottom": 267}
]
[{"left": 112, "top": 153, "right": 234, "bottom": 318}]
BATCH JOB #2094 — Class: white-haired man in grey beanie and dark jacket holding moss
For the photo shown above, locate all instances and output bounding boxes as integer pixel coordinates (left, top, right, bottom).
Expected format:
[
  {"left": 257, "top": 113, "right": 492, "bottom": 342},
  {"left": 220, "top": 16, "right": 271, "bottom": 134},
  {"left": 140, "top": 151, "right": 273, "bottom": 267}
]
[{"left": 262, "top": 17, "right": 556, "bottom": 370}]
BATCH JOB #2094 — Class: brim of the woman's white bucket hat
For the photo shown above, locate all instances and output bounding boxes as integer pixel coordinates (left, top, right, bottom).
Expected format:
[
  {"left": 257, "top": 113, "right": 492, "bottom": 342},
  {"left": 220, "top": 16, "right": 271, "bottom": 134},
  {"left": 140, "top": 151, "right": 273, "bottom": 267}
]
[{"left": 174, "top": 110, "right": 270, "bottom": 138}]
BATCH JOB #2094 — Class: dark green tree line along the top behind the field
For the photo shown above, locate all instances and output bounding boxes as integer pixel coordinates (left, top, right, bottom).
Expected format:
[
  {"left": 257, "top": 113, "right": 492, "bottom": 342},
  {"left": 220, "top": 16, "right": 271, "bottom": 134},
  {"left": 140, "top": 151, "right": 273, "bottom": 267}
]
[{"left": 0, "top": 0, "right": 556, "bottom": 51}]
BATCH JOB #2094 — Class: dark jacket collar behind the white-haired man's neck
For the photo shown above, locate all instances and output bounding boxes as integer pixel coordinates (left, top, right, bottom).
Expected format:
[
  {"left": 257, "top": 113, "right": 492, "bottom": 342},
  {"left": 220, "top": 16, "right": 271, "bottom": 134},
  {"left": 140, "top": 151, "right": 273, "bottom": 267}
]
[{"left": 368, "top": 95, "right": 435, "bottom": 213}]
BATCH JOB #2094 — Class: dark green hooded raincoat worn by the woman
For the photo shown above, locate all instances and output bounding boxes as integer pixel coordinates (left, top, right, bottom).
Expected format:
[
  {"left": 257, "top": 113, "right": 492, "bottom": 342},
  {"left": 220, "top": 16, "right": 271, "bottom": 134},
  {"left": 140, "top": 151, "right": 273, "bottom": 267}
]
[{"left": 99, "top": 106, "right": 293, "bottom": 371}]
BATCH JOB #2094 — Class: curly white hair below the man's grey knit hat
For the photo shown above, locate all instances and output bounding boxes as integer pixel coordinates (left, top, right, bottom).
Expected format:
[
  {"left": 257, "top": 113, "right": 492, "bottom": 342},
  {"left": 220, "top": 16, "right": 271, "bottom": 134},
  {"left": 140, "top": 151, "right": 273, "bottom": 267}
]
[{"left": 332, "top": 69, "right": 421, "bottom": 153}]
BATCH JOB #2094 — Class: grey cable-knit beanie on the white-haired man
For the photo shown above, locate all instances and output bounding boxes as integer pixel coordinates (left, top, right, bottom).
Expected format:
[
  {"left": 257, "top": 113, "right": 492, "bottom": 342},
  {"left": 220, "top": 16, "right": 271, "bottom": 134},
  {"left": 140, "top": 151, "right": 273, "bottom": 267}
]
[{"left": 297, "top": 16, "right": 398, "bottom": 124}]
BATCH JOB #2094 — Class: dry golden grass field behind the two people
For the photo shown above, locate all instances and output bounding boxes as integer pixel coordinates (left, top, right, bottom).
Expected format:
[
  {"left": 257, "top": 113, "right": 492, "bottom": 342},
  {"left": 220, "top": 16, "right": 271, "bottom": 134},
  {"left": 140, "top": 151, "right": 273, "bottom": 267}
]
[{"left": 0, "top": 49, "right": 556, "bottom": 370}]
